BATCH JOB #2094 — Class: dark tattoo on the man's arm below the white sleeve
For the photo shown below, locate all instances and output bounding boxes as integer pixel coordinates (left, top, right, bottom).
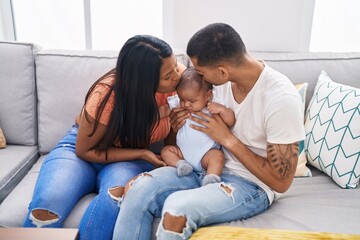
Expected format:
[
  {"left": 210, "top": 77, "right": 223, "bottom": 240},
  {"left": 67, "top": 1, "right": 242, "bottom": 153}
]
[{"left": 263, "top": 143, "right": 299, "bottom": 179}]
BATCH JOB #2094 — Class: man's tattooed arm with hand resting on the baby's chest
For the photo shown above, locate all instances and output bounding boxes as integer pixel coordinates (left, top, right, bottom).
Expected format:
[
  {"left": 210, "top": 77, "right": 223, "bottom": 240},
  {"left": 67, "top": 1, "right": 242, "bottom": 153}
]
[{"left": 191, "top": 113, "right": 299, "bottom": 193}]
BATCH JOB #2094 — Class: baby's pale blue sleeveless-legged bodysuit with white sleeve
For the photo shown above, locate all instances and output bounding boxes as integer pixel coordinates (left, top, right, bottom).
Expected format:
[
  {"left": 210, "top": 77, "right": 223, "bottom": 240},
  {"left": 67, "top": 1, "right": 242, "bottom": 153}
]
[{"left": 168, "top": 95, "right": 221, "bottom": 172}]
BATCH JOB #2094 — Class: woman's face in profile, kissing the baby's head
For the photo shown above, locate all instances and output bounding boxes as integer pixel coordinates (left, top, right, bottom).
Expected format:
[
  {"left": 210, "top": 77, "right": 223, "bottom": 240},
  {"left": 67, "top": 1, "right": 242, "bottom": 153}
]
[{"left": 157, "top": 54, "right": 185, "bottom": 93}]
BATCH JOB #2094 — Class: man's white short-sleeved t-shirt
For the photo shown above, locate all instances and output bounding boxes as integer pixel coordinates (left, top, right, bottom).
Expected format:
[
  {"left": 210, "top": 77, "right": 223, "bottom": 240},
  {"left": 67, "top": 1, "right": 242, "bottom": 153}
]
[{"left": 214, "top": 64, "right": 305, "bottom": 203}]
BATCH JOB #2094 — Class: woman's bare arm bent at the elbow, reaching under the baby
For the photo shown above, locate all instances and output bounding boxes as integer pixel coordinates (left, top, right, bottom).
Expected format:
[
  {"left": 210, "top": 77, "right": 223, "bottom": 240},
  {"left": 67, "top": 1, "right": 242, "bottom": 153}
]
[{"left": 76, "top": 111, "right": 165, "bottom": 166}]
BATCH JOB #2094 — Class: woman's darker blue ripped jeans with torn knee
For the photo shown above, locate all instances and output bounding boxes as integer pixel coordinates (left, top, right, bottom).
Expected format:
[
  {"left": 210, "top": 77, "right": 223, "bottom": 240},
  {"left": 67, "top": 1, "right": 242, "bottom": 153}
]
[{"left": 23, "top": 125, "right": 153, "bottom": 240}]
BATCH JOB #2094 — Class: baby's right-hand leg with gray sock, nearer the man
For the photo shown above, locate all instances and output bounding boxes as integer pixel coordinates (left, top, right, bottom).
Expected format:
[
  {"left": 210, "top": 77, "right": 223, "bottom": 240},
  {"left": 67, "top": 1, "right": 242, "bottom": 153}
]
[{"left": 201, "top": 149, "right": 225, "bottom": 186}]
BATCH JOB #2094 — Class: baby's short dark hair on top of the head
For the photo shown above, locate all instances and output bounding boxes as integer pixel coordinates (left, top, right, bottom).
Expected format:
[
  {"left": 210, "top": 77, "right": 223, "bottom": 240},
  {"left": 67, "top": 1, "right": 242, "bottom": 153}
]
[{"left": 176, "top": 67, "right": 213, "bottom": 91}]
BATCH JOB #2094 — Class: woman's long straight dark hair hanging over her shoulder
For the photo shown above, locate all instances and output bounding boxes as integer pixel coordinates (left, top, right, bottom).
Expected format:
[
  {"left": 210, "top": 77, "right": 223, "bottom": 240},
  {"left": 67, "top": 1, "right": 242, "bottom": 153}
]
[{"left": 85, "top": 35, "right": 172, "bottom": 157}]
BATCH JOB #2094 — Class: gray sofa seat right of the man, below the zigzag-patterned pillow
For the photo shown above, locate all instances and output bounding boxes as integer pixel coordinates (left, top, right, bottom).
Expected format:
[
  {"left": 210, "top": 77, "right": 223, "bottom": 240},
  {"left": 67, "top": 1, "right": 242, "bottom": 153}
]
[{"left": 211, "top": 167, "right": 360, "bottom": 234}]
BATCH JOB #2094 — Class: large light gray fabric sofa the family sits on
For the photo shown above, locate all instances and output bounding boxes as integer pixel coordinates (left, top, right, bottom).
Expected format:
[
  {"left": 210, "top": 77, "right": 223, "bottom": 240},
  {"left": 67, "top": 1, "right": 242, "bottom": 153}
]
[{"left": 0, "top": 42, "right": 360, "bottom": 234}]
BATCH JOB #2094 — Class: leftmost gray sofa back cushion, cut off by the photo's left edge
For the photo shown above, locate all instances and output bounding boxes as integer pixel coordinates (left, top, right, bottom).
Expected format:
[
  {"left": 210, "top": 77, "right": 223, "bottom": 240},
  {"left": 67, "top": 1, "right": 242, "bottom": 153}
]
[{"left": 0, "top": 42, "right": 40, "bottom": 146}]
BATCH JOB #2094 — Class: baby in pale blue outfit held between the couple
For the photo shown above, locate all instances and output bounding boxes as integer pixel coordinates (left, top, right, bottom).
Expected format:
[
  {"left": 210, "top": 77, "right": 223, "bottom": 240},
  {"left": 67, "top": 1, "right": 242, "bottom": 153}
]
[{"left": 161, "top": 68, "right": 235, "bottom": 186}]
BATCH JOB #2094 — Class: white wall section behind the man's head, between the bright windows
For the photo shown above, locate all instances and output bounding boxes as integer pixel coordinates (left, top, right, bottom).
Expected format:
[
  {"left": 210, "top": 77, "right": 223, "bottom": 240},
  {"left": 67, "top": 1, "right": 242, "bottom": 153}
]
[{"left": 163, "top": 0, "right": 315, "bottom": 51}]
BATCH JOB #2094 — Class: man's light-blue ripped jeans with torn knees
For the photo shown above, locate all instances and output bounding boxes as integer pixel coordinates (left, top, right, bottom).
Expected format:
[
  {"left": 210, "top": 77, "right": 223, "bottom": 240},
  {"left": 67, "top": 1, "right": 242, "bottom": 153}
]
[{"left": 113, "top": 167, "right": 269, "bottom": 240}]
